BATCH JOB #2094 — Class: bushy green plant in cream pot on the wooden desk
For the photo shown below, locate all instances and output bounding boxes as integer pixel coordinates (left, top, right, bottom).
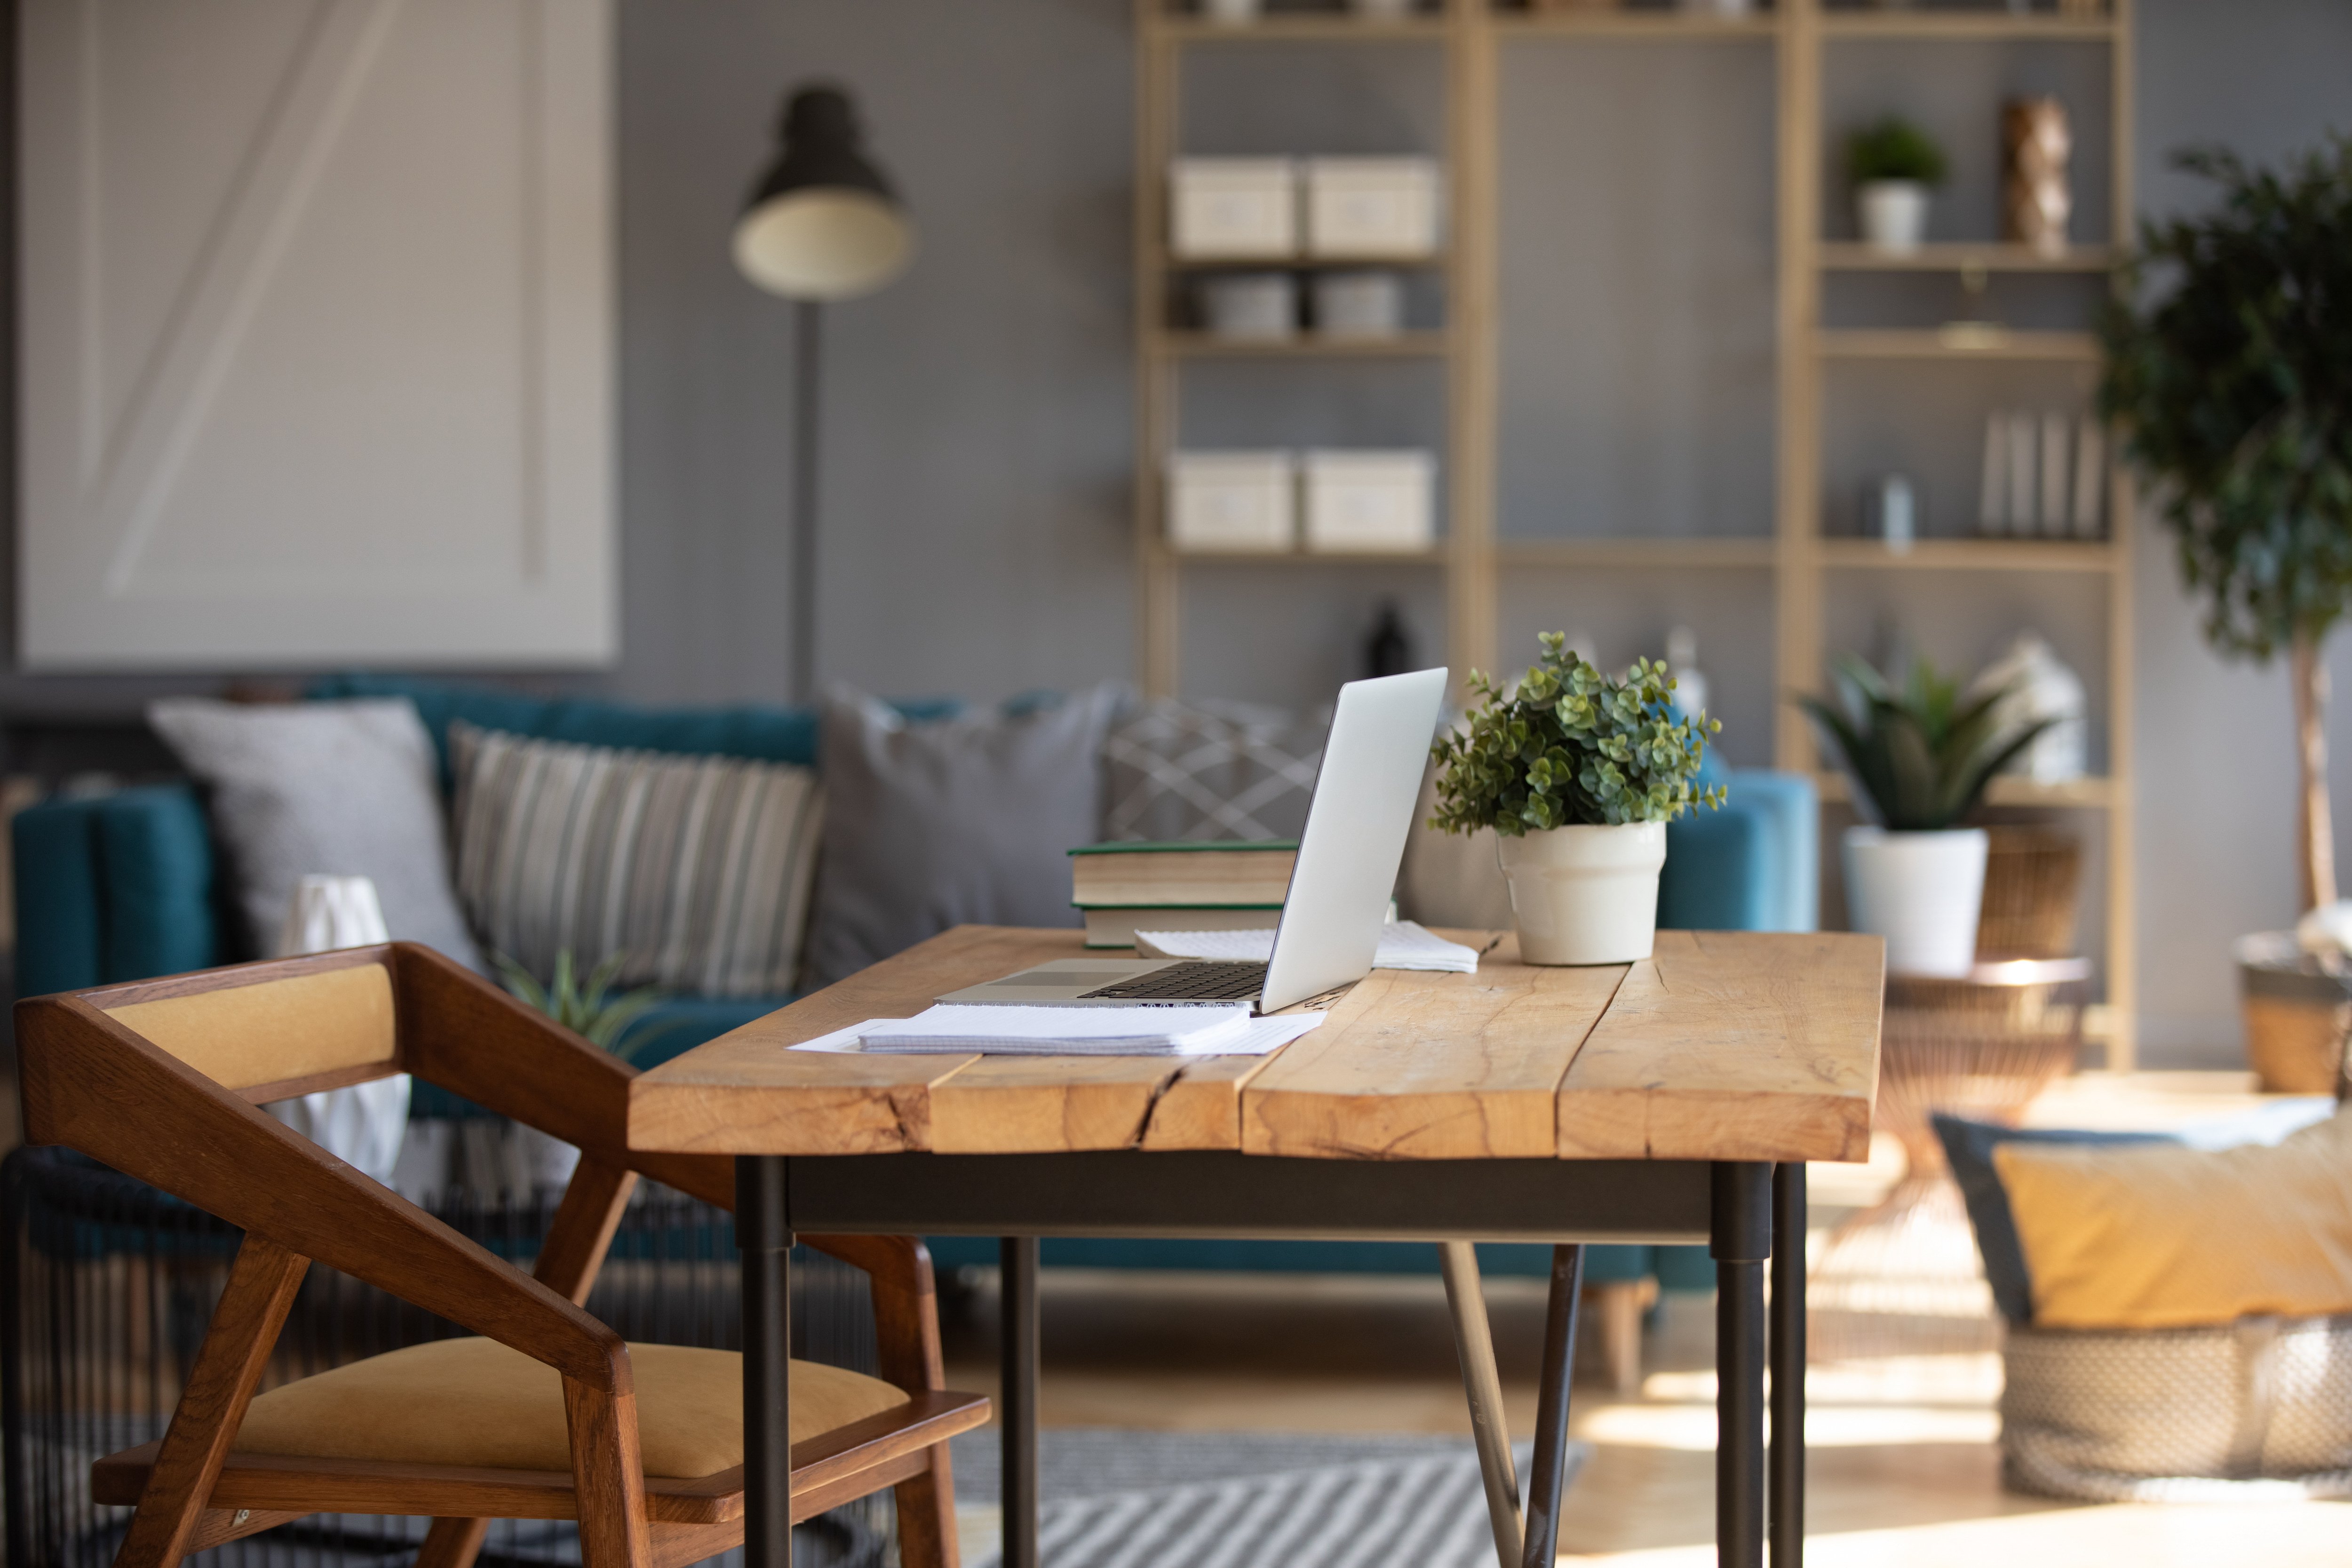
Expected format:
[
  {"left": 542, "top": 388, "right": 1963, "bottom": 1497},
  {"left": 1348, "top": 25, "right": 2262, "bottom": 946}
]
[{"left": 1430, "top": 632, "right": 1724, "bottom": 964}]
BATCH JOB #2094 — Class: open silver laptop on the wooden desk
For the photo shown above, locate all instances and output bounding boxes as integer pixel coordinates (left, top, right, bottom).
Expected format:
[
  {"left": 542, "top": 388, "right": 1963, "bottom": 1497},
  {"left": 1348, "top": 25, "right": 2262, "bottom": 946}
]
[{"left": 938, "top": 670, "right": 1446, "bottom": 1013}]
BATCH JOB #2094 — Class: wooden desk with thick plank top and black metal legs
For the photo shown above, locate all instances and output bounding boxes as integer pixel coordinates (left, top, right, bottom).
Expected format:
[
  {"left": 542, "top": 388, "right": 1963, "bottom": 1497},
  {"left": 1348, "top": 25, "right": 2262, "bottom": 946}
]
[{"left": 628, "top": 926, "right": 1884, "bottom": 1568}]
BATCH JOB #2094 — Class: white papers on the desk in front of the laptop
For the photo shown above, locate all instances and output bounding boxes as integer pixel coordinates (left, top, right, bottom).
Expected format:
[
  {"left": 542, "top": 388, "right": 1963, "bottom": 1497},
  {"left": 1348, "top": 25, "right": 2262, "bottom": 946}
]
[{"left": 793, "top": 1004, "right": 1324, "bottom": 1056}]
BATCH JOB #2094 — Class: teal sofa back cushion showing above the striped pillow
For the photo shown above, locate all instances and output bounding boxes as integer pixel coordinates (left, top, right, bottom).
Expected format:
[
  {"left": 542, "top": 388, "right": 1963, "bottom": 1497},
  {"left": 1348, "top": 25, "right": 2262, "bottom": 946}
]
[{"left": 308, "top": 672, "right": 964, "bottom": 785}]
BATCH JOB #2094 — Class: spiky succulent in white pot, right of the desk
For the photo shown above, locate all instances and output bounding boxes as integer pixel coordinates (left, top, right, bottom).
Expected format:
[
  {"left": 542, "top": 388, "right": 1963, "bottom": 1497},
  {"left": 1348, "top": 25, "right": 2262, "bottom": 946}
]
[{"left": 1797, "top": 653, "right": 2056, "bottom": 978}]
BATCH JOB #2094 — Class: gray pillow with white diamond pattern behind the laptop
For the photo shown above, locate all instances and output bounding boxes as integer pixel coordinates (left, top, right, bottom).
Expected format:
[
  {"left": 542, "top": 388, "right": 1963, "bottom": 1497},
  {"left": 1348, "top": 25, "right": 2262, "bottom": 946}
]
[{"left": 1103, "top": 698, "right": 1331, "bottom": 842}]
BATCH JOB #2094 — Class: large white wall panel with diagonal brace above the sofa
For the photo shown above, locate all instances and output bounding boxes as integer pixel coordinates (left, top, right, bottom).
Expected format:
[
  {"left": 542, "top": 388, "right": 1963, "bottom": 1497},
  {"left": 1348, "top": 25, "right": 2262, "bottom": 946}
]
[{"left": 19, "top": 0, "right": 619, "bottom": 670}]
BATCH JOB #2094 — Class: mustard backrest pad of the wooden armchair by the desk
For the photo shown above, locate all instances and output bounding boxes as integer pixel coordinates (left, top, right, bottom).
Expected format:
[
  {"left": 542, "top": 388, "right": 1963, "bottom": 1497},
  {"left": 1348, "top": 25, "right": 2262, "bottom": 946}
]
[{"left": 106, "top": 964, "right": 393, "bottom": 1089}]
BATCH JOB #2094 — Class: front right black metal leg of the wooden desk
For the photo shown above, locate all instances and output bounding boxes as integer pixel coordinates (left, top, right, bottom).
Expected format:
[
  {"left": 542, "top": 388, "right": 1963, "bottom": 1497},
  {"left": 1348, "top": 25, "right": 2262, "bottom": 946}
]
[{"left": 1708, "top": 1162, "right": 1771, "bottom": 1568}]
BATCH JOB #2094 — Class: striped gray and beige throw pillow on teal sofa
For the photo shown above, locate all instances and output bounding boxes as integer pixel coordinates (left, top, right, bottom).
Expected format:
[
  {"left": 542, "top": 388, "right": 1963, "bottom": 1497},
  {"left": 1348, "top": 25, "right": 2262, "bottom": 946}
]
[{"left": 449, "top": 722, "right": 826, "bottom": 997}]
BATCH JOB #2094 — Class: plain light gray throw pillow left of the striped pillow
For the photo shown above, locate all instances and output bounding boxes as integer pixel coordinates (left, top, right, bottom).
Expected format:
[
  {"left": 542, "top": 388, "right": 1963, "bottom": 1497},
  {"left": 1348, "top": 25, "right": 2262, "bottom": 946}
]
[{"left": 148, "top": 698, "right": 482, "bottom": 969}]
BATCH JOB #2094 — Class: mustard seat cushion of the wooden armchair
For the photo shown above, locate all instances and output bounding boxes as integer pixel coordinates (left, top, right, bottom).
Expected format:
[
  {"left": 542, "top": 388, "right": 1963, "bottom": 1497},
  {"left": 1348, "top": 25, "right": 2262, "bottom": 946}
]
[{"left": 235, "top": 1340, "right": 908, "bottom": 1481}]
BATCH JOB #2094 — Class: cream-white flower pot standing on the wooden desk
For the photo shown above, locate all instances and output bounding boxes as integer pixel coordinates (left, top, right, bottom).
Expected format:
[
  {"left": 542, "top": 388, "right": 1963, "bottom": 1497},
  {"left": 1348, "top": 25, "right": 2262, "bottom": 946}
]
[{"left": 1496, "top": 823, "right": 1665, "bottom": 964}]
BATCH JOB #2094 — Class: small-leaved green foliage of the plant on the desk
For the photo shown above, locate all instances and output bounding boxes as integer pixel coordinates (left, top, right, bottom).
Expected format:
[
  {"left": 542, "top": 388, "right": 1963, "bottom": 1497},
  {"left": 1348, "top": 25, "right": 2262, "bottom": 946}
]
[{"left": 1430, "top": 632, "right": 1724, "bottom": 839}]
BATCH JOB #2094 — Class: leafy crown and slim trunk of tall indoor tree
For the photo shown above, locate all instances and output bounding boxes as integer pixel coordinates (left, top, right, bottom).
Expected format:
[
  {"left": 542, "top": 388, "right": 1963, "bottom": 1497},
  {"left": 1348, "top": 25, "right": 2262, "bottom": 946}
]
[{"left": 2098, "top": 136, "right": 2352, "bottom": 907}]
